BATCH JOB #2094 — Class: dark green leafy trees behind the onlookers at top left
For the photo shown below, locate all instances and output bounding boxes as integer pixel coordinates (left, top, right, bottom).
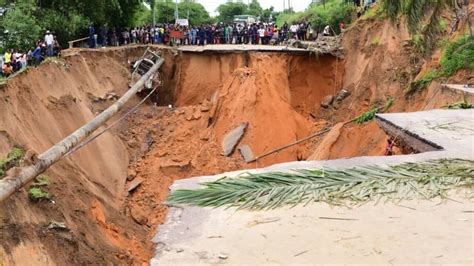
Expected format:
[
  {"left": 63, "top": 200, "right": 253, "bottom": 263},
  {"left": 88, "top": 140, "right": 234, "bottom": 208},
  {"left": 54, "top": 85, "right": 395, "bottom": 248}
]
[{"left": 0, "top": 0, "right": 143, "bottom": 52}]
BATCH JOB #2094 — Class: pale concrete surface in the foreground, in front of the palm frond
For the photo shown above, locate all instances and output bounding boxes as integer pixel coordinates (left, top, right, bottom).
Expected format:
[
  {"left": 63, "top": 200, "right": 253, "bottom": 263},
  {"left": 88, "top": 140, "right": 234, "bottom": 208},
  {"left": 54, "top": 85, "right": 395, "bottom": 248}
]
[{"left": 152, "top": 198, "right": 474, "bottom": 265}]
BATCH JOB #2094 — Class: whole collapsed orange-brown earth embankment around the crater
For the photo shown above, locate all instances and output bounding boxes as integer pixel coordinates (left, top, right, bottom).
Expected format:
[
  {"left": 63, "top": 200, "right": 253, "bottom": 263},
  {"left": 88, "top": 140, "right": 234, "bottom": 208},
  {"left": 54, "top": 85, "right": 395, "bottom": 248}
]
[{"left": 0, "top": 14, "right": 465, "bottom": 265}]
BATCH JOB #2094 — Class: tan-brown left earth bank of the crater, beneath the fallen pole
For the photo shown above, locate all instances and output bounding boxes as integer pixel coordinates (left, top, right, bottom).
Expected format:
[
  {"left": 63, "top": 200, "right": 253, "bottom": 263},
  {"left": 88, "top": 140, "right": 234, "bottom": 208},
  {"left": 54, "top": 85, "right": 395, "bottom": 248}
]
[{"left": 0, "top": 48, "right": 157, "bottom": 265}]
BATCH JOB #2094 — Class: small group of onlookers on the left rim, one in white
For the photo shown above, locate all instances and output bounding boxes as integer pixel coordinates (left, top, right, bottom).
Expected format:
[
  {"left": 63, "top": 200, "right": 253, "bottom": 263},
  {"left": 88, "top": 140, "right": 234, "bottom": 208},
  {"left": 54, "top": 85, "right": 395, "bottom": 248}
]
[{"left": 0, "top": 31, "right": 61, "bottom": 78}]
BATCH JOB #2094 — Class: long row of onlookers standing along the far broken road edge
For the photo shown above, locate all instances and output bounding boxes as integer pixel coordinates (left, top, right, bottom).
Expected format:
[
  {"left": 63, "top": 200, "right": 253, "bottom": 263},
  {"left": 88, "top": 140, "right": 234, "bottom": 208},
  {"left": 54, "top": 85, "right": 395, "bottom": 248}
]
[{"left": 88, "top": 21, "right": 336, "bottom": 48}]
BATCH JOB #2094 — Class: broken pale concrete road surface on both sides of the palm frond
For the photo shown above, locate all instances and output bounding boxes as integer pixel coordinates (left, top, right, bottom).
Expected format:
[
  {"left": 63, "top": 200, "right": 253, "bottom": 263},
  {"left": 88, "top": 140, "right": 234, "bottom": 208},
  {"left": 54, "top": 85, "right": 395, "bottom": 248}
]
[{"left": 151, "top": 110, "right": 474, "bottom": 265}]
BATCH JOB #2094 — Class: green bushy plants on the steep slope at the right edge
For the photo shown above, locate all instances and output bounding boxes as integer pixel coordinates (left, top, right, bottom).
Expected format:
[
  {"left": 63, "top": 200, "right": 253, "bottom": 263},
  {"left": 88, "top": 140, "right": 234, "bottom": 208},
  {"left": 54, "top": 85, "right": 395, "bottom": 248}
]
[{"left": 407, "top": 35, "right": 474, "bottom": 94}]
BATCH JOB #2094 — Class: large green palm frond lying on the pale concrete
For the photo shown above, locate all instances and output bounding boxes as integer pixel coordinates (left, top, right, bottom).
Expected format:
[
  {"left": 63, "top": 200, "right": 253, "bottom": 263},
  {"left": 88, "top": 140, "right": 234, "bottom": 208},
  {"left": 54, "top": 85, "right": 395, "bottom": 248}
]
[{"left": 168, "top": 159, "right": 474, "bottom": 210}]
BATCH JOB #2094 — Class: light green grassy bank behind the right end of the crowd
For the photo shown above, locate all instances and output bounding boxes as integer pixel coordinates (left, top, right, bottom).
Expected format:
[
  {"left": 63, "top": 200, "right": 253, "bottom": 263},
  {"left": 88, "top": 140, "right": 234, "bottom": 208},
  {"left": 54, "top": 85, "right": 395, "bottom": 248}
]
[{"left": 277, "top": 0, "right": 353, "bottom": 33}]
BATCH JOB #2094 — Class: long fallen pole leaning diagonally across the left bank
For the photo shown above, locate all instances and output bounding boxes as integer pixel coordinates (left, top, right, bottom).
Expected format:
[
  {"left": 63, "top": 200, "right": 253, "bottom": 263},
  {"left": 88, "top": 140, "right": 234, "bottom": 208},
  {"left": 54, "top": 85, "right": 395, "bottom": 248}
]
[{"left": 0, "top": 58, "right": 165, "bottom": 202}]
